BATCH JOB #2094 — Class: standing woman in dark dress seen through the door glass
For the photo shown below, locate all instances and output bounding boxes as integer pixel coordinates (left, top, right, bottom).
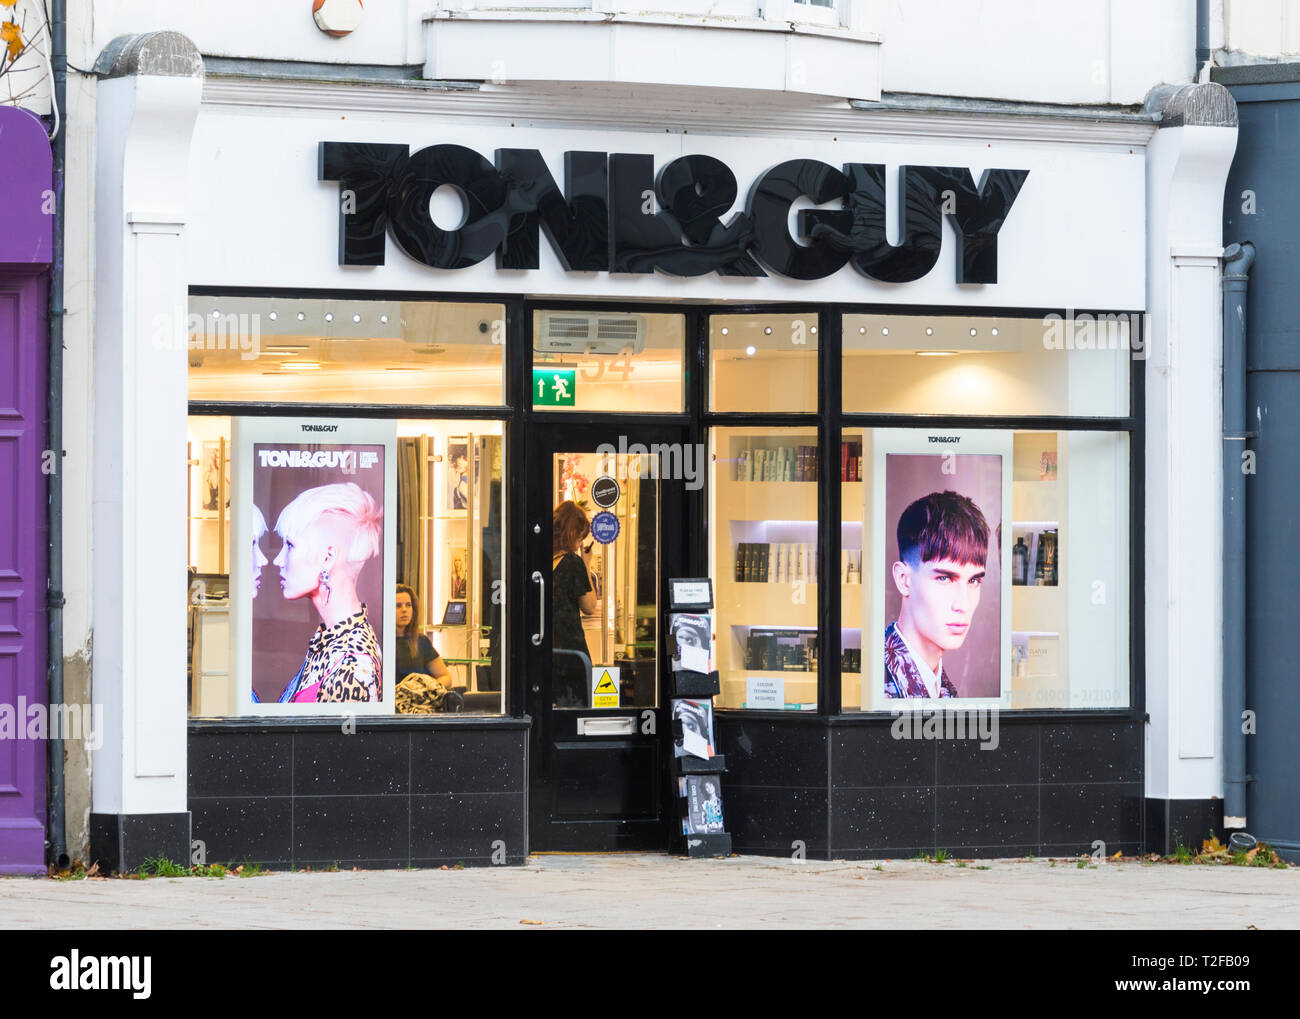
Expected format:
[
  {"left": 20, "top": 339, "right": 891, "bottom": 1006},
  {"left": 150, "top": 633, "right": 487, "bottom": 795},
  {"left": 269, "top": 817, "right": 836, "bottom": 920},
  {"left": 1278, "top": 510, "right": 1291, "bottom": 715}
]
[{"left": 551, "top": 502, "right": 597, "bottom": 707}]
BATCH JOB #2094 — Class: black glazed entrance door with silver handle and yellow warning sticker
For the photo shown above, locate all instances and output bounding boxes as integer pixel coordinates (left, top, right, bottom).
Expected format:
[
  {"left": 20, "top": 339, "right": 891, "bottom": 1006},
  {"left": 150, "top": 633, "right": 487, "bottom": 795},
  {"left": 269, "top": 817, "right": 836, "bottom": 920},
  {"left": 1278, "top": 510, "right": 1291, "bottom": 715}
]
[{"left": 524, "top": 420, "right": 685, "bottom": 851}]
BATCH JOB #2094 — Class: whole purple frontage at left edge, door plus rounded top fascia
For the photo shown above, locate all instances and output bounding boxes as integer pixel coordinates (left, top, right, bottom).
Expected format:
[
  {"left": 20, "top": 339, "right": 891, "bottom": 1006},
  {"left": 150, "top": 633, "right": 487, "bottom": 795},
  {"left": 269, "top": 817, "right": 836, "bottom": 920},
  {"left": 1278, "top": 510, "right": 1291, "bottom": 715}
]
[{"left": 0, "top": 107, "right": 53, "bottom": 873}]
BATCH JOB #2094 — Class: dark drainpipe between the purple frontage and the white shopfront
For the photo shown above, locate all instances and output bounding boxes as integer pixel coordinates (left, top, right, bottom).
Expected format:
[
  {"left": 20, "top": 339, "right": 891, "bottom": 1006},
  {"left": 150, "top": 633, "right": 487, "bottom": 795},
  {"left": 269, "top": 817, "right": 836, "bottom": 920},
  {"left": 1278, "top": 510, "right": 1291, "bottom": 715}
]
[{"left": 46, "top": 0, "right": 70, "bottom": 870}]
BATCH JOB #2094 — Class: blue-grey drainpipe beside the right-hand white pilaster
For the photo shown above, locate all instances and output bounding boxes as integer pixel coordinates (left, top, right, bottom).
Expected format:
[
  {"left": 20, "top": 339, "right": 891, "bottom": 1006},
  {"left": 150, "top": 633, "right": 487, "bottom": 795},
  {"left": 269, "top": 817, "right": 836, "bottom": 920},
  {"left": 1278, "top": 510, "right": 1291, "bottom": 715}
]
[{"left": 1223, "top": 240, "right": 1255, "bottom": 828}]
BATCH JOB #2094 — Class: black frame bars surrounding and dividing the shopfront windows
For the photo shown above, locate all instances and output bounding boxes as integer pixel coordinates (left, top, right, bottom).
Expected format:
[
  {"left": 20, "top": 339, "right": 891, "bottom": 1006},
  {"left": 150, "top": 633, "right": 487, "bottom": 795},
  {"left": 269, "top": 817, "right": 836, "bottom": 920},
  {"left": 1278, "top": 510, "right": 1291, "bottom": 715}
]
[{"left": 189, "top": 285, "right": 1147, "bottom": 728}]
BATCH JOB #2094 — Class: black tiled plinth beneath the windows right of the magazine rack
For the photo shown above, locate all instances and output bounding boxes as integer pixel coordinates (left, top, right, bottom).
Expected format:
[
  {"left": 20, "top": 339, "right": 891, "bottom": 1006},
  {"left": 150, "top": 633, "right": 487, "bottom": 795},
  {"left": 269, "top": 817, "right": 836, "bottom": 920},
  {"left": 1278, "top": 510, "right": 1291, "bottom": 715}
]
[{"left": 716, "top": 711, "right": 1147, "bottom": 859}]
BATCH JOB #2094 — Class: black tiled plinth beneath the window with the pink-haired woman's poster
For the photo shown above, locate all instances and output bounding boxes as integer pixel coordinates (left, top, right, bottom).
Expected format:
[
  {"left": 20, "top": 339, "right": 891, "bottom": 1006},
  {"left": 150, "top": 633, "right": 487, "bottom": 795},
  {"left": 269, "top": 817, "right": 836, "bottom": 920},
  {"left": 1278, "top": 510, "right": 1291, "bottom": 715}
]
[{"left": 190, "top": 719, "right": 528, "bottom": 870}]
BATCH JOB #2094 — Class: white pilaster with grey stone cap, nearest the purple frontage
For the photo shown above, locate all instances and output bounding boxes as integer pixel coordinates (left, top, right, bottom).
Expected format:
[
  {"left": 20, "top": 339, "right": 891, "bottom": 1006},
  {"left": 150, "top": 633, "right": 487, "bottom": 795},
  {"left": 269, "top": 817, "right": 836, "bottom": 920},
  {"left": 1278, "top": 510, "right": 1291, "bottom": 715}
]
[{"left": 91, "top": 32, "right": 203, "bottom": 814}]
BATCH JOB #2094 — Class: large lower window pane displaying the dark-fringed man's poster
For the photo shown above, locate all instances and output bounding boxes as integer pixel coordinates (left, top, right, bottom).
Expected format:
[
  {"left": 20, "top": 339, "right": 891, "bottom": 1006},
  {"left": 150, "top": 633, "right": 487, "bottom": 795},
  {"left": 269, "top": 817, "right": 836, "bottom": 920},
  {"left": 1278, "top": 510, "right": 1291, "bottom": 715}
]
[{"left": 840, "top": 428, "right": 1131, "bottom": 711}]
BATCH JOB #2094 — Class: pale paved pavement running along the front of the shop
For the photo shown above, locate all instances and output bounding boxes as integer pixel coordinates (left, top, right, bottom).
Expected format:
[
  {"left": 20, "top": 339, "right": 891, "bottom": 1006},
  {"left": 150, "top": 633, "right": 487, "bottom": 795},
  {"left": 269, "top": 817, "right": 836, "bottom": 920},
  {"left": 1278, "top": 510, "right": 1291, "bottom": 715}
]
[{"left": 0, "top": 854, "right": 1300, "bottom": 931}]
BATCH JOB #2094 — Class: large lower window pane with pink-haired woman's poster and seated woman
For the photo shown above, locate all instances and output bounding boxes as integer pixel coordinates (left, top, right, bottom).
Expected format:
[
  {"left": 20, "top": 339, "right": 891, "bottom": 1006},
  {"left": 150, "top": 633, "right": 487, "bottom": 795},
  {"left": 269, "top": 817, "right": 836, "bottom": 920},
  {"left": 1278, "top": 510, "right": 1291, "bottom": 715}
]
[{"left": 187, "top": 415, "right": 507, "bottom": 717}]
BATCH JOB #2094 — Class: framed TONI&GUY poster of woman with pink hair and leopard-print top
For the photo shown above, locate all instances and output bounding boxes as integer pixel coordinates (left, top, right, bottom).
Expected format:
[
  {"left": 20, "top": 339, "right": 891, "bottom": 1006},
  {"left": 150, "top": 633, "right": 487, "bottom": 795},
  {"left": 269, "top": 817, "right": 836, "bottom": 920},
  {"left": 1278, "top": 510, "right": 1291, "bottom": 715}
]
[{"left": 231, "top": 419, "right": 397, "bottom": 715}]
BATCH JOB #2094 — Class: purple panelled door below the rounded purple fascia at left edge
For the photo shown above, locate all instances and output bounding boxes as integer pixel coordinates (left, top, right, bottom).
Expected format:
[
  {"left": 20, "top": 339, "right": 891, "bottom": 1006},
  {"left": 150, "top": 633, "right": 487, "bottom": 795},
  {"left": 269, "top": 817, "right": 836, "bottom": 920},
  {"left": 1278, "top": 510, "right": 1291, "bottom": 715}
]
[{"left": 0, "top": 269, "right": 47, "bottom": 873}]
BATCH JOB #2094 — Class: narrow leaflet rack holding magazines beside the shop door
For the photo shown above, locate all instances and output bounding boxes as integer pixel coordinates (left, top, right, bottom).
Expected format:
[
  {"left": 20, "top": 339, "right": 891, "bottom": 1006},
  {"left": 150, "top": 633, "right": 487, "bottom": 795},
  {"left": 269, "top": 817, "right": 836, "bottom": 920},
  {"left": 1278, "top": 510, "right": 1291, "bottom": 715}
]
[{"left": 667, "top": 578, "right": 732, "bottom": 858}]
